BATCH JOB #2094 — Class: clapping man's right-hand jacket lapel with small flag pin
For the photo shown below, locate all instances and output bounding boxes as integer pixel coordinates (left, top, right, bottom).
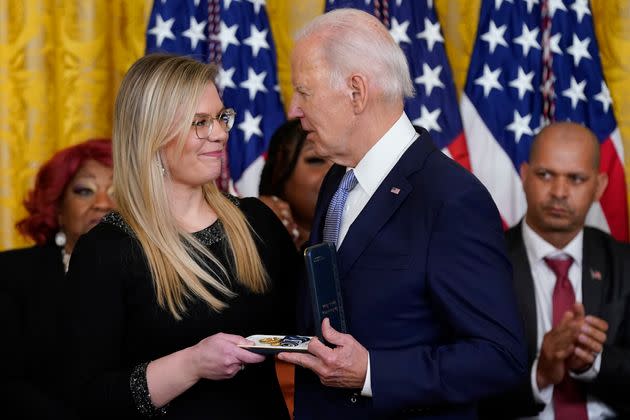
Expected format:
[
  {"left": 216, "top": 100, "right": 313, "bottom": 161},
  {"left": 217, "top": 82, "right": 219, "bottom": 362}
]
[{"left": 582, "top": 228, "right": 609, "bottom": 316}]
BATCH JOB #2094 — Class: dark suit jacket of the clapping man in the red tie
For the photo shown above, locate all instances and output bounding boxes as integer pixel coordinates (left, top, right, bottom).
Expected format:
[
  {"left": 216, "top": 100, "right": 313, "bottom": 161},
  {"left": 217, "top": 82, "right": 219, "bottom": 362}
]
[{"left": 480, "top": 223, "right": 630, "bottom": 420}]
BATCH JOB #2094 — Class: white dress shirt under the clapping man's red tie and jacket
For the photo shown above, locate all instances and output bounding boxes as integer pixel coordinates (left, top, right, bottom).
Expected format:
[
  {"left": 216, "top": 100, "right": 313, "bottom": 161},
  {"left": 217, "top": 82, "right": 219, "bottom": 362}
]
[{"left": 522, "top": 220, "right": 614, "bottom": 420}]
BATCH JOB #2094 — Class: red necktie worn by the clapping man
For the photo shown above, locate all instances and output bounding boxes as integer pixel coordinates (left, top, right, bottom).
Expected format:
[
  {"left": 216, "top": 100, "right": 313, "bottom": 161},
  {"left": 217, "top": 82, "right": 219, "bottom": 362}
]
[{"left": 545, "top": 258, "right": 588, "bottom": 420}]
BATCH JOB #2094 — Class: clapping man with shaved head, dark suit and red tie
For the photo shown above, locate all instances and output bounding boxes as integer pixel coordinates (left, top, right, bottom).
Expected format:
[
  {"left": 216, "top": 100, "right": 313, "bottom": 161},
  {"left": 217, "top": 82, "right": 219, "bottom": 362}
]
[{"left": 480, "top": 122, "right": 630, "bottom": 420}]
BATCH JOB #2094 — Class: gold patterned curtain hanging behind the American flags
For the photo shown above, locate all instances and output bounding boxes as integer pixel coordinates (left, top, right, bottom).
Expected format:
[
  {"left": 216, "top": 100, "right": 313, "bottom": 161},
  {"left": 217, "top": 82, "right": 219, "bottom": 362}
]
[{"left": 0, "top": 0, "right": 630, "bottom": 250}]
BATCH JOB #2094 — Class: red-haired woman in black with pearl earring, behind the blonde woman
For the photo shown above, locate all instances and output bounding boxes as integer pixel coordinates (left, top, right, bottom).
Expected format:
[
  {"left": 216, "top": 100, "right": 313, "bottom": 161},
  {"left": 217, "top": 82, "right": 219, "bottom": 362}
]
[{"left": 0, "top": 139, "right": 114, "bottom": 419}]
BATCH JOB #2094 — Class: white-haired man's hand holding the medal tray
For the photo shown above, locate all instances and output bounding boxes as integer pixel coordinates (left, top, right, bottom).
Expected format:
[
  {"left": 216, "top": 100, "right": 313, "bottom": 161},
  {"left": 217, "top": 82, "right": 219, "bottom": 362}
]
[{"left": 278, "top": 318, "right": 369, "bottom": 389}]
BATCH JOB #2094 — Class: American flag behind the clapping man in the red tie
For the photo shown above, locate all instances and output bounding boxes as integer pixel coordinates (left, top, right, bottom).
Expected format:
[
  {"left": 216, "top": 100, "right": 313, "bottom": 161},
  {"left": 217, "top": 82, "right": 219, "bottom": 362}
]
[{"left": 460, "top": 0, "right": 628, "bottom": 241}]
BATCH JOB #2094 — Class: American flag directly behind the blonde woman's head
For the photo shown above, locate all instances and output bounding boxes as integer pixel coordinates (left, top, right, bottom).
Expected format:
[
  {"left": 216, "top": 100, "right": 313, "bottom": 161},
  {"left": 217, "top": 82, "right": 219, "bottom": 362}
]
[{"left": 146, "top": 0, "right": 285, "bottom": 196}]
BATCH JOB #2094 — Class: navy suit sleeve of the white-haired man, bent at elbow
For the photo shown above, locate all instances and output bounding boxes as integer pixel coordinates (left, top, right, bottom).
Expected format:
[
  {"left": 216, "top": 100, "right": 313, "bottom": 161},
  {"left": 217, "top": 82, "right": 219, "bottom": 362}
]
[{"left": 370, "top": 184, "right": 527, "bottom": 410}]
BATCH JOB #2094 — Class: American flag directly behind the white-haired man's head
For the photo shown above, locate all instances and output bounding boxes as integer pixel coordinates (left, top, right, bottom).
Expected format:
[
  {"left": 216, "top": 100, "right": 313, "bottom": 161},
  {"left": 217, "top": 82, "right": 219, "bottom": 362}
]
[{"left": 326, "top": 0, "right": 470, "bottom": 169}]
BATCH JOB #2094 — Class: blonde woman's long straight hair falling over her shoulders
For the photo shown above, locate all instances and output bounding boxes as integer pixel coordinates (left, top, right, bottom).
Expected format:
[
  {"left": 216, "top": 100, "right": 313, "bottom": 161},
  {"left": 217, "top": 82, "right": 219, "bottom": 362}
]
[{"left": 113, "top": 54, "right": 268, "bottom": 319}]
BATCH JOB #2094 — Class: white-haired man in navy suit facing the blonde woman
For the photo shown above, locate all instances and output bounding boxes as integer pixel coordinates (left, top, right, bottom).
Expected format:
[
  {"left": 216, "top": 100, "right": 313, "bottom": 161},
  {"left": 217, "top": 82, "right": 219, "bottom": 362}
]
[{"left": 279, "top": 9, "right": 526, "bottom": 420}]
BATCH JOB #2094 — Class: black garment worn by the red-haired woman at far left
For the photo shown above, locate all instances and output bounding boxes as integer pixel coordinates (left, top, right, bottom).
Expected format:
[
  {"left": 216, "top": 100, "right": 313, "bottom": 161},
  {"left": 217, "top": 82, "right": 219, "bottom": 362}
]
[{"left": 0, "top": 244, "right": 79, "bottom": 419}]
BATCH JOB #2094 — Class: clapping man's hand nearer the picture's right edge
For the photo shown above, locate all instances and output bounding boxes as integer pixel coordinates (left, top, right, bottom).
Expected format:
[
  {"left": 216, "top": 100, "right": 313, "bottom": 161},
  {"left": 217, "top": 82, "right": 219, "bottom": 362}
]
[{"left": 567, "top": 310, "right": 608, "bottom": 373}]
